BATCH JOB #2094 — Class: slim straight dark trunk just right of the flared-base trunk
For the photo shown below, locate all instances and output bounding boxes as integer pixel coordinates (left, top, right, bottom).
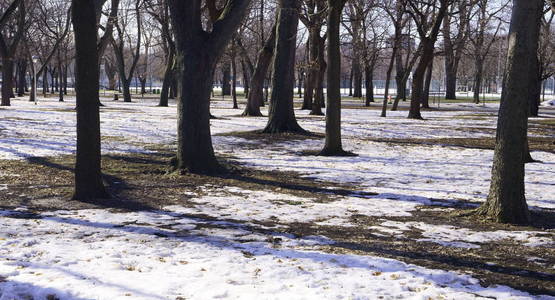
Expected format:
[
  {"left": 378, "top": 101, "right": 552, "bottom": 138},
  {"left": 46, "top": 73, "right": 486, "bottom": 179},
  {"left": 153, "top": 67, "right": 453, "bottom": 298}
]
[{"left": 320, "top": 0, "right": 347, "bottom": 156}]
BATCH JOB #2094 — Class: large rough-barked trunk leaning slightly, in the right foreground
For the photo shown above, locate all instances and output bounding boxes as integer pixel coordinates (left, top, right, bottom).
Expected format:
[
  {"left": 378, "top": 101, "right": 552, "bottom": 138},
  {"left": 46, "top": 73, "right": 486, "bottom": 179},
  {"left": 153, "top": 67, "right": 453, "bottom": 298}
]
[{"left": 478, "top": 0, "right": 543, "bottom": 224}]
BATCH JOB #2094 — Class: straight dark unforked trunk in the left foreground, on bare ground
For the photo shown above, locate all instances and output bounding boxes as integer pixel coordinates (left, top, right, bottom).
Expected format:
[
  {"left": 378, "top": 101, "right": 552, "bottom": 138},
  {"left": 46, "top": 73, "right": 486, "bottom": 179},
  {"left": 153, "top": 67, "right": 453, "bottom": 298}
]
[{"left": 72, "top": 0, "right": 109, "bottom": 201}]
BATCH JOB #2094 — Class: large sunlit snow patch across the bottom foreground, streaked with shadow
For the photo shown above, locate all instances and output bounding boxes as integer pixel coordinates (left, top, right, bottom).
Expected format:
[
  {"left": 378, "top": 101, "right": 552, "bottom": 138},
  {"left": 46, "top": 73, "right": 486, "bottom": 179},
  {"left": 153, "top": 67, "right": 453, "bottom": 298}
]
[{"left": 0, "top": 210, "right": 548, "bottom": 299}]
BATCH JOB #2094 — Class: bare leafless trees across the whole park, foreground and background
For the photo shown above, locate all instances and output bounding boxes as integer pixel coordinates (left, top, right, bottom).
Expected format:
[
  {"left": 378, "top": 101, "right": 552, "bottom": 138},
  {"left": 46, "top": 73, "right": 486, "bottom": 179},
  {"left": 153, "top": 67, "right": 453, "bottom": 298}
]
[{"left": 0, "top": 0, "right": 552, "bottom": 223}]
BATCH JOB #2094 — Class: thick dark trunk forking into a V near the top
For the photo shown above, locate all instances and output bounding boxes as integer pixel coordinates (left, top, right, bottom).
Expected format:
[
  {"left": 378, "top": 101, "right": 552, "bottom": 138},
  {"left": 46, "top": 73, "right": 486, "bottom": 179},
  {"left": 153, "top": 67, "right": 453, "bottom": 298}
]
[{"left": 169, "top": 0, "right": 250, "bottom": 174}]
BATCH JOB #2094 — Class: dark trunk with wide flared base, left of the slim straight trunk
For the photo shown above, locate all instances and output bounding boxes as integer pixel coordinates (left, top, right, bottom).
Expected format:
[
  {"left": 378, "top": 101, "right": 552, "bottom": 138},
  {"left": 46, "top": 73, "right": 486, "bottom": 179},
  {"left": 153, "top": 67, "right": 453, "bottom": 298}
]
[{"left": 263, "top": 0, "right": 304, "bottom": 133}]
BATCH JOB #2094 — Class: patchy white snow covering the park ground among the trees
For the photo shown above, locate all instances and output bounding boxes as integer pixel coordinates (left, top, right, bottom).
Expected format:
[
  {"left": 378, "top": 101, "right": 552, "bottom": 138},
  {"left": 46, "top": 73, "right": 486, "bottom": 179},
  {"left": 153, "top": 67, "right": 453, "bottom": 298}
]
[{"left": 0, "top": 100, "right": 555, "bottom": 300}]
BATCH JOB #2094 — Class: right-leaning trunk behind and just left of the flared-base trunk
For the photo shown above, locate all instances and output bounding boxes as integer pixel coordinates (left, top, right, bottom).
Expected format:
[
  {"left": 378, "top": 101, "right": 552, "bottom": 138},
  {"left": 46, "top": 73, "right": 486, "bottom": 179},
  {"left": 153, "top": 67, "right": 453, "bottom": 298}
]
[{"left": 243, "top": 25, "right": 276, "bottom": 117}]
